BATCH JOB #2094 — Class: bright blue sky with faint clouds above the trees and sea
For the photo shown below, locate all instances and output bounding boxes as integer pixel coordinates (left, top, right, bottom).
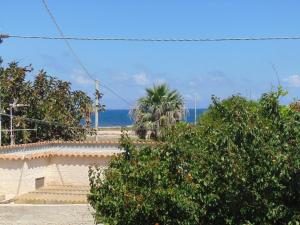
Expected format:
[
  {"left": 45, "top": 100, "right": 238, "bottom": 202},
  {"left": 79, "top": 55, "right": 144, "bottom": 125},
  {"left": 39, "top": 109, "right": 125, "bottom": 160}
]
[{"left": 0, "top": 0, "right": 300, "bottom": 109}]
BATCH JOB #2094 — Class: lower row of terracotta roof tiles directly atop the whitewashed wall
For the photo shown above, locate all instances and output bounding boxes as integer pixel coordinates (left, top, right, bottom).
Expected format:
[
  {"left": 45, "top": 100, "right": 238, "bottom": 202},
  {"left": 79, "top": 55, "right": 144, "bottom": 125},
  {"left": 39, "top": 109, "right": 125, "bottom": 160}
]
[{"left": 0, "top": 152, "right": 120, "bottom": 160}]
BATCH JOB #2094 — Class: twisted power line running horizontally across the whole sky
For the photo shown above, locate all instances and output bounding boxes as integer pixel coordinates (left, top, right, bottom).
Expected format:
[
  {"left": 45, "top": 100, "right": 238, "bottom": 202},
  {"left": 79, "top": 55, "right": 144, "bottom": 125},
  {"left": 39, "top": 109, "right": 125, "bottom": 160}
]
[{"left": 0, "top": 34, "right": 300, "bottom": 42}]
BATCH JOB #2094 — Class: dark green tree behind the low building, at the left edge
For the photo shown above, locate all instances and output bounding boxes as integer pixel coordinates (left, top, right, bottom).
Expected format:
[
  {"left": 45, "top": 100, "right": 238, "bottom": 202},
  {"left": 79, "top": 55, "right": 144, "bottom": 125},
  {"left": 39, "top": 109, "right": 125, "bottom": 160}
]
[{"left": 0, "top": 62, "right": 92, "bottom": 144}]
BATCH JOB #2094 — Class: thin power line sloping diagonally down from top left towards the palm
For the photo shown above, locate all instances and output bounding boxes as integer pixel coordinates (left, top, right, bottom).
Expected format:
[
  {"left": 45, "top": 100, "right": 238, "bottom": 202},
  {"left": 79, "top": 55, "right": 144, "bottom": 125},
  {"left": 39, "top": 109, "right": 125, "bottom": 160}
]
[{"left": 40, "top": 0, "right": 132, "bottom": 106}]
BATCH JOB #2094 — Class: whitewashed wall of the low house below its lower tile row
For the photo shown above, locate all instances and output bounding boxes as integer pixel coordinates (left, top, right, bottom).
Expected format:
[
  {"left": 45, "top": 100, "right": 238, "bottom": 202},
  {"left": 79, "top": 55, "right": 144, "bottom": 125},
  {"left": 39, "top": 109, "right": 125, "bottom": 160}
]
[{"left": 0, "top": 156, "right": 110, "bottom": 199}]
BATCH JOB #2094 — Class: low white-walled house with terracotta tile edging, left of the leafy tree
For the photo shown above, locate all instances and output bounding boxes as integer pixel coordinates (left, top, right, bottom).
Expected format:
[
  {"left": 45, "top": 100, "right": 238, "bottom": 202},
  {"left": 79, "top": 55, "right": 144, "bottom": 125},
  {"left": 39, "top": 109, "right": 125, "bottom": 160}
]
[{"left": 0, "top": 141, "right": 121, "bottom": 200}]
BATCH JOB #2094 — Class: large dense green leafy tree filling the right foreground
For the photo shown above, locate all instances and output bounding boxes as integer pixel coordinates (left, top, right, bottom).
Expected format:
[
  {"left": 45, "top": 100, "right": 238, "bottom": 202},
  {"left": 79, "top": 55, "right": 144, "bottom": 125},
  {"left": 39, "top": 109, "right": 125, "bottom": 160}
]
[{"left": 89, "top": 89, "right": 300, "bottom": 225}]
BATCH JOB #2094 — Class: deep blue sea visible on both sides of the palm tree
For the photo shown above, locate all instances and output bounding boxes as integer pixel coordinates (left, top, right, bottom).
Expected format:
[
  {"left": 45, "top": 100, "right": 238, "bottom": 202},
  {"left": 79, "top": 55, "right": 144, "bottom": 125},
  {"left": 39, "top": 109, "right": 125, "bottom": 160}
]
[{"left": 91, "top": 109, "right": 207, "bottom": 127}]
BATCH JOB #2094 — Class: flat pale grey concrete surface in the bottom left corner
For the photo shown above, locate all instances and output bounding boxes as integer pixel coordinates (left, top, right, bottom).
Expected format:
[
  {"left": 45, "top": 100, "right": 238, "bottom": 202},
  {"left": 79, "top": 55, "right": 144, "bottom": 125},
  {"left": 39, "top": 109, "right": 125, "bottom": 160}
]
[{"left": 0, "top": 204, "right": 101, "bottom": 225}]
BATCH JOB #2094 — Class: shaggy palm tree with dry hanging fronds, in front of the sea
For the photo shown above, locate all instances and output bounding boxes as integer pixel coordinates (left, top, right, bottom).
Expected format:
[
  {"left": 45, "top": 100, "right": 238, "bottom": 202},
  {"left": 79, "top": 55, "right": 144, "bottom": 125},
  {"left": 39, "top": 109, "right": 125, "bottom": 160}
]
[{"left": 130, "top": 84, "right": 185, "bottom": 139}]
